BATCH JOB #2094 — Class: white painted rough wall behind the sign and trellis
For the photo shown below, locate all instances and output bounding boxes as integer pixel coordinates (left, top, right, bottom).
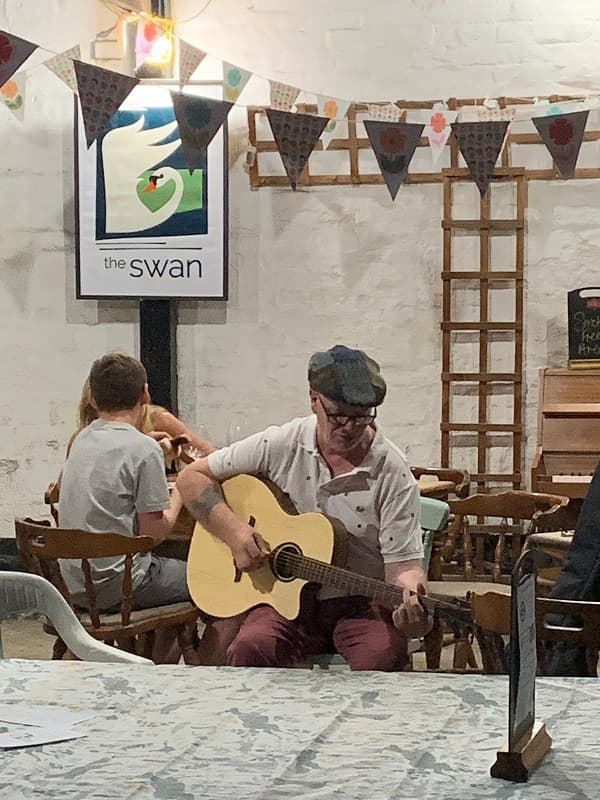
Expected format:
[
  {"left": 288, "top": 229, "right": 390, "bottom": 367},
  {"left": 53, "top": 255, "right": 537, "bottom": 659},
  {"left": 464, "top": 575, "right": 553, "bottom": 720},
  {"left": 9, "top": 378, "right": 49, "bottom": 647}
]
[{"left": 0, "top": 0, "right": 600, "bottom": 536}]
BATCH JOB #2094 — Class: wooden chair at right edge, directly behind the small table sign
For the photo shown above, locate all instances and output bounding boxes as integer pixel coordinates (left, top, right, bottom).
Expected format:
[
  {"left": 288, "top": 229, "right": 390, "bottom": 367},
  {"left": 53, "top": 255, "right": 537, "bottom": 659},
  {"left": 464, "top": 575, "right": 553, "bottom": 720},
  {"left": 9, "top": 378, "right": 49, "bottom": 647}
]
[{"left": 471, "top": 592, "right": 600, "bottom": 677}]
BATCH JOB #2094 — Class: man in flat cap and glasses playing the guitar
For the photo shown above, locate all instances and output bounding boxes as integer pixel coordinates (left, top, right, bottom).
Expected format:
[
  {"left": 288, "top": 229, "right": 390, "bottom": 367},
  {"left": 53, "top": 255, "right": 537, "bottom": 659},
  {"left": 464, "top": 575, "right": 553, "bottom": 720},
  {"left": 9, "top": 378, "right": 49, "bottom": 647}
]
[{"left": 177, "top": 345, "right": 431, "bottom": 671}]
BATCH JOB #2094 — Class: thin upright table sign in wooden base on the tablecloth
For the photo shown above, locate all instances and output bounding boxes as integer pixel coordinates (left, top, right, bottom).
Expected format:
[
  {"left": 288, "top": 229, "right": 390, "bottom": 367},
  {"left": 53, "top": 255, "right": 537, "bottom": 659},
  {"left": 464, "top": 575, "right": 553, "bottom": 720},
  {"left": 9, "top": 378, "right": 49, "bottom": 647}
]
[{"left": 490, "top": 550, "right": 552, "bottom": 782}]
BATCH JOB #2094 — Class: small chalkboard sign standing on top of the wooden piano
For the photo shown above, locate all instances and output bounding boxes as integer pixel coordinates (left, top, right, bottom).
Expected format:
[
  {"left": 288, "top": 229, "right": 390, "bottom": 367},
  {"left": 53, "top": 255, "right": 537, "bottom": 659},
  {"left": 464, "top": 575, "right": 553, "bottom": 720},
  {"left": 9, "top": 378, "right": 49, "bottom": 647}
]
[{"left": 568, "top": 287, "right": 600, "bottom": 367}]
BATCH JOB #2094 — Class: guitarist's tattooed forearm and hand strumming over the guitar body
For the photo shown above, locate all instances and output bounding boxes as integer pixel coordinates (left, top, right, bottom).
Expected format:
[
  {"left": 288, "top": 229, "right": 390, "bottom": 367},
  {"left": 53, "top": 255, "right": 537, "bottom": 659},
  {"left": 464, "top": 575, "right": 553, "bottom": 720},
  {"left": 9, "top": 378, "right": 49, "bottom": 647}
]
[{"left": 177, "top": 458, "right": 269, "bottom": 571}]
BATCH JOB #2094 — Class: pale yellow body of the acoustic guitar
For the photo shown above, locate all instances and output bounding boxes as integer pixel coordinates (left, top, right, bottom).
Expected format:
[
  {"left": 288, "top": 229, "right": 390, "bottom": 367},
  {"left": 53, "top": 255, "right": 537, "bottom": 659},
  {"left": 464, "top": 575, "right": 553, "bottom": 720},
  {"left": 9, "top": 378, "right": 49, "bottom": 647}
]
[{"left": 187, "top": 475, "right": 335, "bottom": 619}]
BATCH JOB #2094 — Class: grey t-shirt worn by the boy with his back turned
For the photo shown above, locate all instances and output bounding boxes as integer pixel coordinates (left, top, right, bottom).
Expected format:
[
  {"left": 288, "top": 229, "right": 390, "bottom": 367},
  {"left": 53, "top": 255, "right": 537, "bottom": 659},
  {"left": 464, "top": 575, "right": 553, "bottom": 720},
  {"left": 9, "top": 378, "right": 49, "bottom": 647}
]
[{"left": 59, "top": 419, "right": 170, "bottom": 608}]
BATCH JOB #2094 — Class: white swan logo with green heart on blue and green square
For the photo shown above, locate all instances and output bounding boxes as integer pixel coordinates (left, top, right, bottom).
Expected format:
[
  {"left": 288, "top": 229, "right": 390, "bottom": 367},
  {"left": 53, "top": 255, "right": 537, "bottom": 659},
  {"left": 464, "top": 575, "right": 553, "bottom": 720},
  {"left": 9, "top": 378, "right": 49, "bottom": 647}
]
[{"left": 96, "top": 107, "right": 208, "bottom": 239}]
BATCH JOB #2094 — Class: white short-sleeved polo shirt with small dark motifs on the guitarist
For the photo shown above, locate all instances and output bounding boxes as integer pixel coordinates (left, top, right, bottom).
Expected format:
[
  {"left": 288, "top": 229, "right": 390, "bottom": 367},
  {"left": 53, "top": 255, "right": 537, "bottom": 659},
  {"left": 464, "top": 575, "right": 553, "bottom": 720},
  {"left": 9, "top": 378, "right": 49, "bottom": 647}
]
[{"left": 208, "top": 414, "right": 423, "bottom": 598}]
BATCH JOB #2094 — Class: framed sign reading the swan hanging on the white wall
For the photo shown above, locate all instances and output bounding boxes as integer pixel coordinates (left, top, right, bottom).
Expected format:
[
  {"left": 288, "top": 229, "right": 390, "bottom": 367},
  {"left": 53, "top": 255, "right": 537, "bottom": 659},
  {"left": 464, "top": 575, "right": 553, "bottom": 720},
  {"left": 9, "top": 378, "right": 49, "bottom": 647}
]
[{"left": 75, "top": 83, "right": 228, "bottom": 300}]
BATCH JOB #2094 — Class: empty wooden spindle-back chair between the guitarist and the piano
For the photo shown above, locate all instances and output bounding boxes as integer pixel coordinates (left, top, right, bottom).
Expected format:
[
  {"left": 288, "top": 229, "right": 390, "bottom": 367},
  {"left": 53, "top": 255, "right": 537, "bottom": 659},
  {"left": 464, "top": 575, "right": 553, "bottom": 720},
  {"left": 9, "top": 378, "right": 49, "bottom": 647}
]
[{"left": 442, "top": 491, "right": 569, "bottom": 581}]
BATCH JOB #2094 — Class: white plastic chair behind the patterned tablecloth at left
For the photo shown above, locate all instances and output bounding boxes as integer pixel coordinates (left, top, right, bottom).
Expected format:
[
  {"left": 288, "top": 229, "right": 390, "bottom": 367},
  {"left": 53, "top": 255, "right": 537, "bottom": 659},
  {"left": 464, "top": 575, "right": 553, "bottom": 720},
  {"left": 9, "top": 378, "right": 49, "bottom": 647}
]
[{"left": 0, "top": 572, "right": 152, "bottom": 664}]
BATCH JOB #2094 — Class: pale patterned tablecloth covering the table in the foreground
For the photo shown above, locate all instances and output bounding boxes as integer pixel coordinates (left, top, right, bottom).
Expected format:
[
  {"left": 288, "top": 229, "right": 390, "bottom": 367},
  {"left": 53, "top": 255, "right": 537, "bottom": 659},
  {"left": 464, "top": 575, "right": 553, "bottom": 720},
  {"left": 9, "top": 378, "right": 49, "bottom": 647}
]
[{"left": 0, "top": 660, "right": 600, "bottom": 800}]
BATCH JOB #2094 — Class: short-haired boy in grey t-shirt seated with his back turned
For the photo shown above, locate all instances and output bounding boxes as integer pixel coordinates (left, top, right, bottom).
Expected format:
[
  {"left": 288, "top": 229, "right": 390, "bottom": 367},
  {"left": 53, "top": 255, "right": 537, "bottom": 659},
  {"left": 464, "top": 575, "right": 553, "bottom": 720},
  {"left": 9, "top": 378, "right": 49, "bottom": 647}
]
[{"left": 60, "top": 353, "right": 190, "bottom": 610}]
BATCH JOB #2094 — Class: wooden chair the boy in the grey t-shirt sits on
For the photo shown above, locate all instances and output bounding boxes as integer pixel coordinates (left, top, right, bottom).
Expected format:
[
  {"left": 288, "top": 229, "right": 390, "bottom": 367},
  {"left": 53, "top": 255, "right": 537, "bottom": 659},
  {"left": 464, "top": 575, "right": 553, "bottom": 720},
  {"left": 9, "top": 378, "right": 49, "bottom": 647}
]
[{"left": 15, "top": 519, "right": 199, "bottom": 664}]
